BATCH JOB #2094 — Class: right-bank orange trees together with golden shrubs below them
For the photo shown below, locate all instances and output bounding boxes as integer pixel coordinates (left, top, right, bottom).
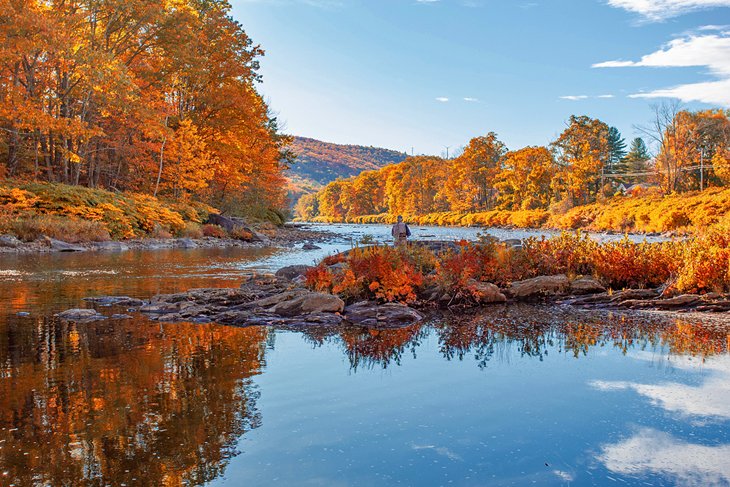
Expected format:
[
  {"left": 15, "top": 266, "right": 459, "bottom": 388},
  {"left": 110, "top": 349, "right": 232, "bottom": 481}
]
[{"left": 295, "top": 112, "right": 730, "bottom": 238}]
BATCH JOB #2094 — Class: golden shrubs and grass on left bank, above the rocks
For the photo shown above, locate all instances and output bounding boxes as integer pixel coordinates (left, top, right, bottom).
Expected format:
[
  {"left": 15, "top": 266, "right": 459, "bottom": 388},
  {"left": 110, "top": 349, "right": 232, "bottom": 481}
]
[{"left": 0, "top": 180, "right": 282, "bottom": 243}]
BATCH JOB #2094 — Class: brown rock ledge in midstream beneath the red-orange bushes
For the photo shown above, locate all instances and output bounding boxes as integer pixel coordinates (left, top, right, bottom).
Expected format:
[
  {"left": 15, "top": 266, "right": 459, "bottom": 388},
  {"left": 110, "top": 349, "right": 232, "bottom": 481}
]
[{"left": 57, "top": 255, "right": 730, "bottom": 328}]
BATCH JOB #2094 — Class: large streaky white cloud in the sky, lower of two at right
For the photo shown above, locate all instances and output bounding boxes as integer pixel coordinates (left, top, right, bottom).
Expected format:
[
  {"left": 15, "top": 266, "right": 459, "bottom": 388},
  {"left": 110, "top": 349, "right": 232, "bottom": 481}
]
[{"left": 593, "top": 33, "right": 730, "bottom": 107}]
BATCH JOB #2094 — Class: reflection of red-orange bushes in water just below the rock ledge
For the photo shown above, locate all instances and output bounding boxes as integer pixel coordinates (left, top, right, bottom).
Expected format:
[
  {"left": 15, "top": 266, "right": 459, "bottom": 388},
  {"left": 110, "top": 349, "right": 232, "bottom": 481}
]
[{"left": 294, "top": 305, "right": 730, "bottom": 370}]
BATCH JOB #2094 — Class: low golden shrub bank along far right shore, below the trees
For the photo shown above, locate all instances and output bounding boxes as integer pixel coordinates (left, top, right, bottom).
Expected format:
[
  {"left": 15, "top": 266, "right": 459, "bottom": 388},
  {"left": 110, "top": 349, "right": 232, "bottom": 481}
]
[{"left": 317, "top": 188, "right": 730, "bottom": 234}]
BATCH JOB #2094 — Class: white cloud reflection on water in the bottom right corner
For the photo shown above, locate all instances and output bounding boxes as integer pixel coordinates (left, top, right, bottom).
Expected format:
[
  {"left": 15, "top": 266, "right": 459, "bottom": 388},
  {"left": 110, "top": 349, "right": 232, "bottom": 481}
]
[{"left": 597, "top": 428, "right": 730, "bottom": 486}]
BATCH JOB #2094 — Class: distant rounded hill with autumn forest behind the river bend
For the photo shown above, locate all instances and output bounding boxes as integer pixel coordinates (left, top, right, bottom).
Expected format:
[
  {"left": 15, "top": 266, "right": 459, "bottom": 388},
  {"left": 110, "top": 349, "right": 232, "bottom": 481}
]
[{"left": 287, "top": 137, "right": 406, "bottom": 202}]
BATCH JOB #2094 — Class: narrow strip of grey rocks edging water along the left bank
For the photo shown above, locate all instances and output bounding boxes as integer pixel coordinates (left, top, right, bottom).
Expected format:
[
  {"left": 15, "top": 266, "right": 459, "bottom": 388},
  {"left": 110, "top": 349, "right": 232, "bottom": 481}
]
[{"left": 0, "top": 224, "right": 333, "bottom": 254}]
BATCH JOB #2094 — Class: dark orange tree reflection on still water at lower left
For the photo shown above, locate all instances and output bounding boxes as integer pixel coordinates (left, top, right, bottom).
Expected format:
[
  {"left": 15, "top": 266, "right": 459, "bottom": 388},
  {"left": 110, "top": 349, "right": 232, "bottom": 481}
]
[{"left": 0, "top": 320, "right": 267, "bottom": 485}]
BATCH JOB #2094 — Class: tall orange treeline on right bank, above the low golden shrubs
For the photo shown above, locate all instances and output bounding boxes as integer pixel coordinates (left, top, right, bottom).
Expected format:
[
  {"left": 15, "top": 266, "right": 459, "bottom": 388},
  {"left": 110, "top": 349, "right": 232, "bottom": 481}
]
[{"left": 296, "top": 109, "right": 730, "bottom": 221}]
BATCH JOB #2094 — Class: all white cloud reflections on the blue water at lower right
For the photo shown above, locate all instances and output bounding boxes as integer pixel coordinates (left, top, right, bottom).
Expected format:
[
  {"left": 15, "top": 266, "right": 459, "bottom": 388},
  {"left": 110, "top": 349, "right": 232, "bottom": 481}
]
[{"left": 591, "top": 354, "right": 730, "bottom": 486}]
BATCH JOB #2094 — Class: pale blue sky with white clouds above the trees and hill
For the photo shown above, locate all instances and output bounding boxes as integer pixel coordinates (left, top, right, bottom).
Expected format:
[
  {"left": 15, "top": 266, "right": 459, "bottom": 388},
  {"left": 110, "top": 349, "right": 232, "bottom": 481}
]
[{"left": 231, "top": 0, "right": 730, "bottom": 155}]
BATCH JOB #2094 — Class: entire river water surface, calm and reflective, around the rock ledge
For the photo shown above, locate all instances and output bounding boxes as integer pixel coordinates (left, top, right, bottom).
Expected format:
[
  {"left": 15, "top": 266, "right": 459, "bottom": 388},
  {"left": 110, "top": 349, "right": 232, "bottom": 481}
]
[{"left": 0, "top": 225, "right": 730, "bottom": 486}]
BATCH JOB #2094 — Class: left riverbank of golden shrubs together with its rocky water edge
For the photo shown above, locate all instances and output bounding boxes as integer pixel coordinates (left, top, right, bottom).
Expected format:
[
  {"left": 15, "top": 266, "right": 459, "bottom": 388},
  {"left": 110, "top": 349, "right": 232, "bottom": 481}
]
[{"left": 0, "top": 181, "right": 325, "bottom": 252}]
